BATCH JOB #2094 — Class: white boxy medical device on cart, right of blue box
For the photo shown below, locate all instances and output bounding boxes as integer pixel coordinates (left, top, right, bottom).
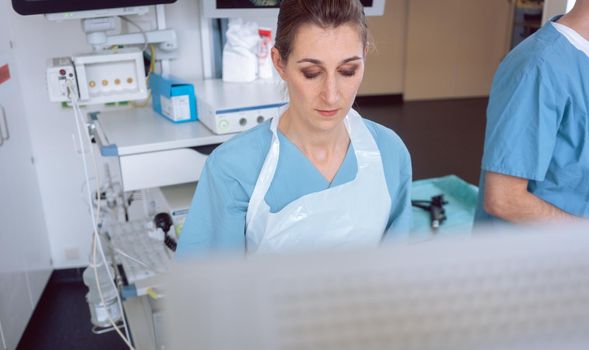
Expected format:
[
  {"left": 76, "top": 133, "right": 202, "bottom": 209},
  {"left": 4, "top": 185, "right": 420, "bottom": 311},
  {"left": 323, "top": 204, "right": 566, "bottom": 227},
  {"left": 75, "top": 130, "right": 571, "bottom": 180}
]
[{"left": 194, "top": 79, "right": 287, "bottom": 134}]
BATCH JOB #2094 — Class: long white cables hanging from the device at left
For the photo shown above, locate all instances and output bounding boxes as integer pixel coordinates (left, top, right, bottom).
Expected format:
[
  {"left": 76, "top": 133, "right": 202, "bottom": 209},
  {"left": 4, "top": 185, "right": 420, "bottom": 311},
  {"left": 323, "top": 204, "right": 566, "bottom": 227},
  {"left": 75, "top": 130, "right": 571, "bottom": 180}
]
[{"left": 67, "top": 81, "right": 134, "bottom": 350}]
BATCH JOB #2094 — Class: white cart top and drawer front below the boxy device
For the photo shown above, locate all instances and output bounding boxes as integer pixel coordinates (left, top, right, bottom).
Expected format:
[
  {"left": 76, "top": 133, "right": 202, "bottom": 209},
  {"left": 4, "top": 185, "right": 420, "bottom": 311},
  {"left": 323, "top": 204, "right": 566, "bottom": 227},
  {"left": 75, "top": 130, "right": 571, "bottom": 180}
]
[{"left": 96, "top": 108, "right": 235, "bottom": 191}]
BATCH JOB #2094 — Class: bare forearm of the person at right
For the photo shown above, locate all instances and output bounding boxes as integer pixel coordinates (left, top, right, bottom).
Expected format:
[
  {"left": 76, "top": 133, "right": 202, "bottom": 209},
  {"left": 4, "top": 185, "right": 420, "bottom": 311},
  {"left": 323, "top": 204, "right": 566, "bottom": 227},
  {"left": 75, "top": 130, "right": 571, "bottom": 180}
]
[{"left": 483, "top": 172, "right": 580, "bottom": 223}]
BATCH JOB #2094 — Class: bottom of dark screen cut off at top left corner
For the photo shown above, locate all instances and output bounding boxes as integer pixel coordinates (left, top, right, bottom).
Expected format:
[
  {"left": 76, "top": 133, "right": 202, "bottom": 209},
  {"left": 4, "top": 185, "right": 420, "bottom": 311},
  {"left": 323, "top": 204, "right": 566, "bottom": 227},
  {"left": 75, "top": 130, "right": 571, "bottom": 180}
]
[{"left": 12, "top": 0, "right": 176, "bottom": 15}]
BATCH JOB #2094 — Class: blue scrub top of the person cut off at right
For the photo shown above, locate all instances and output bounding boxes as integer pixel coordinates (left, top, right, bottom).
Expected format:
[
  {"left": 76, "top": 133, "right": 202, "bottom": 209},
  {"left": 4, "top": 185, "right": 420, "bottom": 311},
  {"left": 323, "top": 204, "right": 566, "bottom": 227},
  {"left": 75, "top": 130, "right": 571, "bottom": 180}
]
[{"left": 476, "top": 18, "right": 589, "bottom": 221}]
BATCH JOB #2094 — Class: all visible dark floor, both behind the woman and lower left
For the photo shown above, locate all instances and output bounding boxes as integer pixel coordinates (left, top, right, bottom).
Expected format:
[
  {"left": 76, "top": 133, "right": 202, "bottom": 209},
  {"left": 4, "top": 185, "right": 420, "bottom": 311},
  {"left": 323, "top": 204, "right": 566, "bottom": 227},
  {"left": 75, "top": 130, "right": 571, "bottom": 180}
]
[{"left": 18, "top": 98, "right": 487, "bottom": 350}]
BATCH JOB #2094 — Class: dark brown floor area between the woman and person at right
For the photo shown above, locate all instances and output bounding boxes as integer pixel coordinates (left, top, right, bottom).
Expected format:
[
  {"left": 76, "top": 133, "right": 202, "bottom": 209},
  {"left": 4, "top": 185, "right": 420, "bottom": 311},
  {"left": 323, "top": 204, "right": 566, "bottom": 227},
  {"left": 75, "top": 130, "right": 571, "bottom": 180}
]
[{"left": 357, "top": 94, "right": 488, "bottom": 185}]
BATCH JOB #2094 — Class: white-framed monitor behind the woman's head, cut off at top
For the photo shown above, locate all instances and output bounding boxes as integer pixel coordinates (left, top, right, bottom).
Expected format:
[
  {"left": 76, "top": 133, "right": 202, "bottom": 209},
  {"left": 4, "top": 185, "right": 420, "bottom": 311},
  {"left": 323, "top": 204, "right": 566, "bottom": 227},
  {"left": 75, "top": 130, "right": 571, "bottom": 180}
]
[{"left": 202, "top": 0, "right": 385, "bottom": 18}]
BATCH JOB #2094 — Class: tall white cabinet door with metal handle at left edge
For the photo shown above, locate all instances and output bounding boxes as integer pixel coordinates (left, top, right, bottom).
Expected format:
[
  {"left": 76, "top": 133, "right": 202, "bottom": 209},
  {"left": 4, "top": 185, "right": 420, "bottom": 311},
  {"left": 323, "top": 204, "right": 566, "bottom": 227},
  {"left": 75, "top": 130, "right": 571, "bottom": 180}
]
[{"left": 0, "top": 1, "right": 51, "bottom": 349}]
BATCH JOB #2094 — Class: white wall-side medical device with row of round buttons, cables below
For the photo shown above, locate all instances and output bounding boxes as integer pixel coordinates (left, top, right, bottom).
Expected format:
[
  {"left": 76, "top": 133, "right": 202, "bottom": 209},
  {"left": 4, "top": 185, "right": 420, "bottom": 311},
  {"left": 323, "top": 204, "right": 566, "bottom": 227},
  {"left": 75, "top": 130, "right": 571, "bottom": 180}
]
[{"left": 47, "top": 48, "right": 148, "bottom": 105}]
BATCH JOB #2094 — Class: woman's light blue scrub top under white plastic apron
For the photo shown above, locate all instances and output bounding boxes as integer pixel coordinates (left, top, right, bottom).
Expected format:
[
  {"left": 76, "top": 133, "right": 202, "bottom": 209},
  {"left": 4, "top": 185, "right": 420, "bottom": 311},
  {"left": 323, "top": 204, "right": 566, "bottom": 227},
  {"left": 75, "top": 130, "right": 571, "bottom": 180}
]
[{"left": 176, "top": 119, "right": 411, "bottom": 258}]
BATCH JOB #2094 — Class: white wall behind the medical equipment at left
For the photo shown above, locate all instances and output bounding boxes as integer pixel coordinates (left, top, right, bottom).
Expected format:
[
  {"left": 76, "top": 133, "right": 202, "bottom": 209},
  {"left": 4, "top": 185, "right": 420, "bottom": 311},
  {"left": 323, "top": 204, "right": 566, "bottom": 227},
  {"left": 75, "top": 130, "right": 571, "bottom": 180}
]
[{"left": 3, "top": 0, "right": 202, "bottom": 268}]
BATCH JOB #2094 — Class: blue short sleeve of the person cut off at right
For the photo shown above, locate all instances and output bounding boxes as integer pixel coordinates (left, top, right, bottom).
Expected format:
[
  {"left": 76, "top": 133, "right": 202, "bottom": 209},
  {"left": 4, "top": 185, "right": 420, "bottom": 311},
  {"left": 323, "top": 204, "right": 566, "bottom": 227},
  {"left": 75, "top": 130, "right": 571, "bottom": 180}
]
[{"left": 482, "top": 65, "right": 561, "bottom": 181}]
